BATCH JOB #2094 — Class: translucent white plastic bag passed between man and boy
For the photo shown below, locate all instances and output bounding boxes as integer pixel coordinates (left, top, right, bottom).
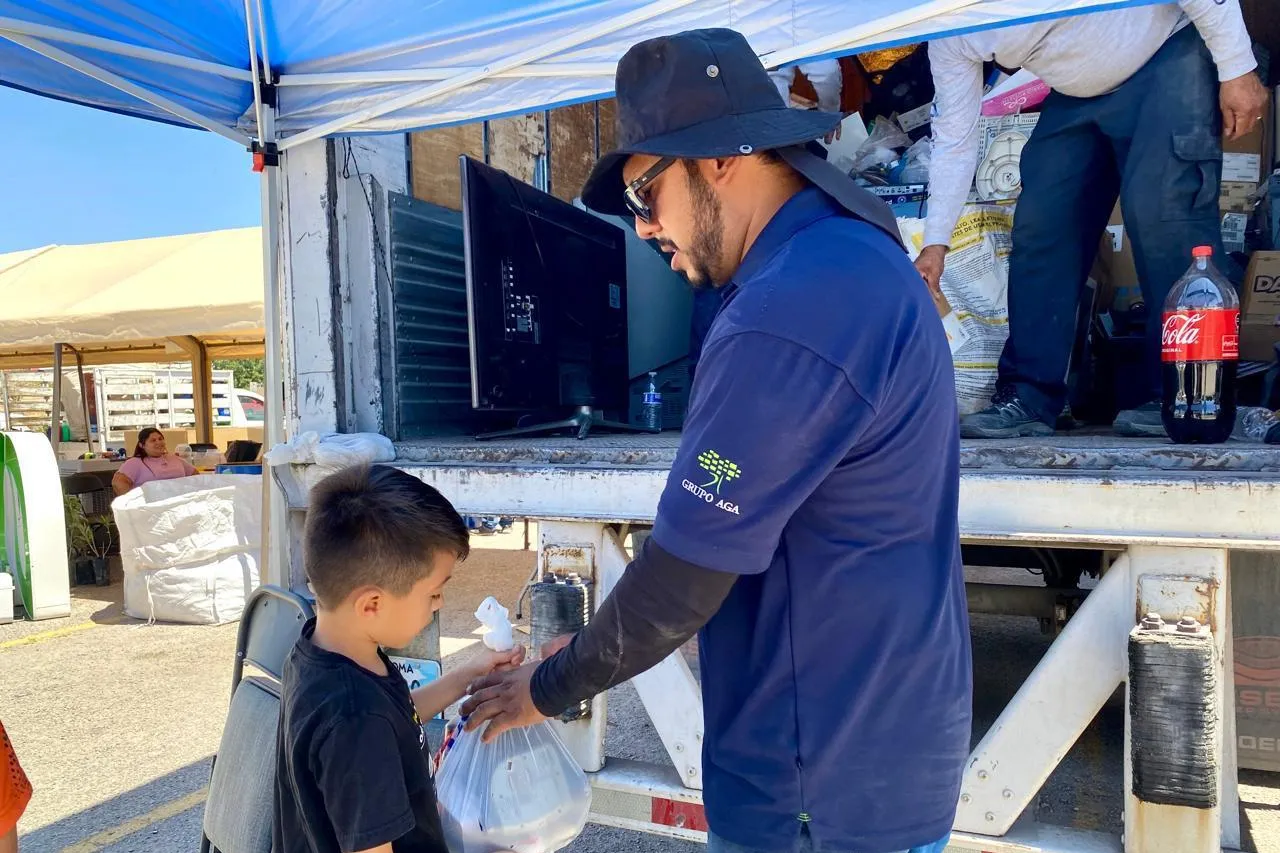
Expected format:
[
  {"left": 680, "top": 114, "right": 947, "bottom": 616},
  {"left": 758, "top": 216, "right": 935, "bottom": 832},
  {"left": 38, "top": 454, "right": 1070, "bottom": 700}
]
[{"left": 435, "top": 598, "right": 591, "bottom": 853}]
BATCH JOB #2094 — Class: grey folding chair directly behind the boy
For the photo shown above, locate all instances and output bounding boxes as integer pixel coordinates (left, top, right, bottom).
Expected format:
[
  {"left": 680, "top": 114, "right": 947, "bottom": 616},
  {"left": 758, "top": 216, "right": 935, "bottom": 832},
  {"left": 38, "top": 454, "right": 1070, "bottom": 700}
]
[{"left": 200, "top": 587, "right": 314, "bottom": 853}]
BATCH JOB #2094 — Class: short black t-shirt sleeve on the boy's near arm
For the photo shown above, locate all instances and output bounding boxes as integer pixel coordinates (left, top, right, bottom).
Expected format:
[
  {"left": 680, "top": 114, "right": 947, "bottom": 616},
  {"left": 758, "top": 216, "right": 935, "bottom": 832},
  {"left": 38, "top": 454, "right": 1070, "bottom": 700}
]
[{"left": 312, "top": 715, "right": 416, "bottom": 853}]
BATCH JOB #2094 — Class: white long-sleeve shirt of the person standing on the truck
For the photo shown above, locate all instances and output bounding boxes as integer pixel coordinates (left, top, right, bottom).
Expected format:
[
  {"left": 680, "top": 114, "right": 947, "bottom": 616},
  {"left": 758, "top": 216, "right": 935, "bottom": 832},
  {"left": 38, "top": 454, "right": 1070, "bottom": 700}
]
[{"left": 924, "top": 0, "right": 1257, "bottom": 246}]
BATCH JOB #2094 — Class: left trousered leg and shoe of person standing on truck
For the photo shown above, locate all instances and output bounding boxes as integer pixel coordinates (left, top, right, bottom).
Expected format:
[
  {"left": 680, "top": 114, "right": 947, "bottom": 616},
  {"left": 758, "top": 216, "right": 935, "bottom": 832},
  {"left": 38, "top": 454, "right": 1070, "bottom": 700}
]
[{"left": 960, "top": 92, "right": 1120, "bottom": 438}]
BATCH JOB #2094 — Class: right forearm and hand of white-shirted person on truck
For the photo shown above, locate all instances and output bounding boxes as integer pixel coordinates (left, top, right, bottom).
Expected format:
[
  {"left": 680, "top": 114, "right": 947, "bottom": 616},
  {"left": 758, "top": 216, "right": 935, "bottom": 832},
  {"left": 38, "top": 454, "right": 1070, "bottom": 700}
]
[{"left": 1178, "top": 0, "right": 1270, "bottom": 140}]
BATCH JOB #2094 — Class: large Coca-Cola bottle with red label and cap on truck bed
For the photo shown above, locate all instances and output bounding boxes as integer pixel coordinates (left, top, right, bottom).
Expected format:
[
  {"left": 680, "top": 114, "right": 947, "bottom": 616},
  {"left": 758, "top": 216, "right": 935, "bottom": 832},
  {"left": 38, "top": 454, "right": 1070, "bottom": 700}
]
[{"left": 1160, "top": 246, "right": 1240, "bottom": 444}]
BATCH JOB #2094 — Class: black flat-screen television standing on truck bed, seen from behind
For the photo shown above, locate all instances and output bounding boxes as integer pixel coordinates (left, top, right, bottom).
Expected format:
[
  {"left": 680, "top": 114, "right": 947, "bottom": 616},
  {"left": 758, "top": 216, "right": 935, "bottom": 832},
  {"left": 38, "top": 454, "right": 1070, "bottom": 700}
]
[{"left": 462, "top": 156, "right": 630, "bottom": 421}]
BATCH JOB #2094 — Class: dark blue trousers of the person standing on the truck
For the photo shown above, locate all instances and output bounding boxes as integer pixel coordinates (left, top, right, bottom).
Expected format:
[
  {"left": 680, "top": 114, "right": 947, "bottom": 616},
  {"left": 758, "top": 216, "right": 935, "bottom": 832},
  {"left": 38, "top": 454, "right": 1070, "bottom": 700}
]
[{"left": 997, "top": 26, "right": 1238, "bottom": 424}]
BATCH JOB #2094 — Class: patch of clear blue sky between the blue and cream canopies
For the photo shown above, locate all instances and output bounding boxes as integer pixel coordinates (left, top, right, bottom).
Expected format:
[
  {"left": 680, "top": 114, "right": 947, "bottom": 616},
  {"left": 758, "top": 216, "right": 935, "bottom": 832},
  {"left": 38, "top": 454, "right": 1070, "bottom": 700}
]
[{"left": 0, "top": 86, "right": 261, "bottom": 252}]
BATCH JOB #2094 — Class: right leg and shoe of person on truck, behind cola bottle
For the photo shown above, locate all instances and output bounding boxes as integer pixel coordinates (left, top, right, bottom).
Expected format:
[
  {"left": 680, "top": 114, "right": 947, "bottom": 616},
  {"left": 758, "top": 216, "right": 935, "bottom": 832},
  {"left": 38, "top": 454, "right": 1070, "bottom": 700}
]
[{"left": 1103, "top": 27, "right": 1239, "bottom": 437}]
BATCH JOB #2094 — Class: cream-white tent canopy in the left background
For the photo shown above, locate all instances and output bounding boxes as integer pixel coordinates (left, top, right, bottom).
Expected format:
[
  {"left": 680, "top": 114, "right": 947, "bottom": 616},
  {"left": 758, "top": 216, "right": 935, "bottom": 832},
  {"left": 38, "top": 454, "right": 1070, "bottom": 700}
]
[{"left": 0, "top": 228, "right": 265, "bottom": 366}]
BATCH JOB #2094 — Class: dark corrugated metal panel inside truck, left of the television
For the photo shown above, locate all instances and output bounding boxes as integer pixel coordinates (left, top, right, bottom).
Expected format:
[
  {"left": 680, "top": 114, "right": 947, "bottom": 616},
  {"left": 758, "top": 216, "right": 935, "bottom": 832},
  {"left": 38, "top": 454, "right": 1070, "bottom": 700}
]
[{"left": 383, "top": 192, "right": 472, "bottom": 439}]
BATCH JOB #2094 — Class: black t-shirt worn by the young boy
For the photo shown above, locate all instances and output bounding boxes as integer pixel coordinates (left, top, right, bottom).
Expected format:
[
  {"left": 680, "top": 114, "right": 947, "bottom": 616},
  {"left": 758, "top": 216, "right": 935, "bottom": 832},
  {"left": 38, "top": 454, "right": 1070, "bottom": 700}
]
[{"left": 273, "top": 620, "right": 448, "bottom": 853}]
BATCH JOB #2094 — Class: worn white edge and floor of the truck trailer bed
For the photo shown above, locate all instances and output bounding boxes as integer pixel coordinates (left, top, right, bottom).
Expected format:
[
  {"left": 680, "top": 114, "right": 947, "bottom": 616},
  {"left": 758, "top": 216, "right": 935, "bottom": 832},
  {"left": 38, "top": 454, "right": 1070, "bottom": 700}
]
[{"left": 396, "top": 433, "right": 1280, "bottom": 549}]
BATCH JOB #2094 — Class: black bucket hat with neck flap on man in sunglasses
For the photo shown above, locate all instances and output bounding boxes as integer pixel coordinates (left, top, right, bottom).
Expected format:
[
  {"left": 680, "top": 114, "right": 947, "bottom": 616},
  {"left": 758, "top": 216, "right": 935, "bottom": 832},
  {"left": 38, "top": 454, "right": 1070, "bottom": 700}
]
[{"left": 582, "top": 29, "right": 901, "bottom": 245}]
